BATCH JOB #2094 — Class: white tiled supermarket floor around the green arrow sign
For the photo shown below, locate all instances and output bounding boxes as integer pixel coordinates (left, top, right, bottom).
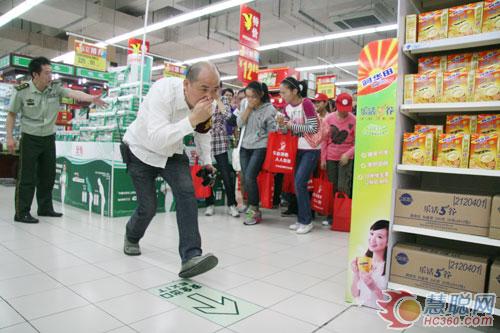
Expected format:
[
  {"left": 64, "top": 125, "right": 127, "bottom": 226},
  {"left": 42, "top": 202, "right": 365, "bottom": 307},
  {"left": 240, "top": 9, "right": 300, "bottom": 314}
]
[{"left": 0, "top": 187, "right": 500, "bottom": 333}]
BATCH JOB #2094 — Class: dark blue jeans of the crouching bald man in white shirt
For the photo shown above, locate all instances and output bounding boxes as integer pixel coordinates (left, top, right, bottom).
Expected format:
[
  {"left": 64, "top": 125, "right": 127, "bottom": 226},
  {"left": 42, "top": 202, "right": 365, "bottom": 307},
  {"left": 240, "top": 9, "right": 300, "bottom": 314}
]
[{"left": 126, "top": 151, "right": 202, "bottom": 263}]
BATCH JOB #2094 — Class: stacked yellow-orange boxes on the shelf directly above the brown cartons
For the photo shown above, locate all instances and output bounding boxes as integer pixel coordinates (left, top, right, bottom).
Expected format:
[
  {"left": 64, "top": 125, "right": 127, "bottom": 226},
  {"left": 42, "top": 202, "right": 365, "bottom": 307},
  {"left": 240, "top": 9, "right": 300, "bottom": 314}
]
[{"left": 402, "top": 114, "right": 500, "bottom": 170}]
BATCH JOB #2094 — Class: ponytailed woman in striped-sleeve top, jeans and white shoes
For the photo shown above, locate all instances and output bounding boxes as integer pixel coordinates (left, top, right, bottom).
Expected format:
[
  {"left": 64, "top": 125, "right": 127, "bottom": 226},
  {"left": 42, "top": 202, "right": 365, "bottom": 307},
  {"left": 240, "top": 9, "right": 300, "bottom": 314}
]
[{"left": 279, "top": 76, "right": 321, "bottom": 235}]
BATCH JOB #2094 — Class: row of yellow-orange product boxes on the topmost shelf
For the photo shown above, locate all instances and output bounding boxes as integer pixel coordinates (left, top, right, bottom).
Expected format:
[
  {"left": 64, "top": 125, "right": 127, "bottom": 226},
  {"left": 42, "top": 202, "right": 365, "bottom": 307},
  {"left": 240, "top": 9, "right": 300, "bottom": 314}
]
[{"left": 406, "top": 0, "right": 500, "bottom": 43}]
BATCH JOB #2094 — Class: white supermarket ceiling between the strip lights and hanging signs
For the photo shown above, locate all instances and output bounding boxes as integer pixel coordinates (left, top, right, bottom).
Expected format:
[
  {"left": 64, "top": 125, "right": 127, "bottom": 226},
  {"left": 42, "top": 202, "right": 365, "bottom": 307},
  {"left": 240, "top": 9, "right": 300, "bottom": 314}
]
[{"left": 0, "top": 0, "right": 397, "bottom": 80}]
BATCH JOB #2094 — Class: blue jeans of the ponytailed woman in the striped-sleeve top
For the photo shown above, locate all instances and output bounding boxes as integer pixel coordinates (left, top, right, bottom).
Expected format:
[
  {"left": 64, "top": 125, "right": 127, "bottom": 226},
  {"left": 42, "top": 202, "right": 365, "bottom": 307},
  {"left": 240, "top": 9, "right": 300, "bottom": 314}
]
[{"left": 295, "top": 149, "right": 320, "bottom": 224}]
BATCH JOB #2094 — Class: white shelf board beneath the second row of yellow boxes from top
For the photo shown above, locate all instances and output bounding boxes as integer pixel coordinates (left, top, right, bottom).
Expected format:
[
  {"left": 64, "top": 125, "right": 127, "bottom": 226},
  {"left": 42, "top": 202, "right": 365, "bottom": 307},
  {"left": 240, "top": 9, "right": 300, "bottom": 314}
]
[{"left": 400, "top": 101, "right": 500, "bottom": 118}]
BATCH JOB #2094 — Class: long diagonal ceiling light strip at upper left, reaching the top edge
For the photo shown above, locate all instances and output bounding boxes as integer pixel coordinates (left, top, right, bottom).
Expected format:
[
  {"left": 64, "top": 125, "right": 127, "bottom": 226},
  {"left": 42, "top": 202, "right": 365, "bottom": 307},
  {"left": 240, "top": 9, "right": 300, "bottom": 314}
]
[{"left": 52, "top": 0, "right": 255, "bottom": 63}]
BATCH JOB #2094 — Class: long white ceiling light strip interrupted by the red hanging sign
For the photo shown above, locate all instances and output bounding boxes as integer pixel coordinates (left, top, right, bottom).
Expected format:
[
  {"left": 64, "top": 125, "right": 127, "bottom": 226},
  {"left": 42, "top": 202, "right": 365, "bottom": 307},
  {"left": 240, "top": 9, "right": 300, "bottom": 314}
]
[{"left": 174, "top": 24, "right": 398, "bottom": 64}]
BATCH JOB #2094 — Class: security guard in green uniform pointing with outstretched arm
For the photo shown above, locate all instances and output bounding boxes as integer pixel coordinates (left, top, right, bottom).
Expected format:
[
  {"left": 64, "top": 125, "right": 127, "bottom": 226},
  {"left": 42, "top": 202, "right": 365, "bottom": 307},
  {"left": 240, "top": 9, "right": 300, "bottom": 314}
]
[{"left": 7, "top": 57, "right": 106, "bottom": 223}]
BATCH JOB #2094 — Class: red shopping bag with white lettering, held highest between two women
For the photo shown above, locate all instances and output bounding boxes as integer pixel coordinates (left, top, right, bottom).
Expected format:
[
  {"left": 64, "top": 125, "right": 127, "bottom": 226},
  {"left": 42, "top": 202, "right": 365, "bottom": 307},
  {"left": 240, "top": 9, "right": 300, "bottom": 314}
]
[{"left": 262, "top": 132, "right": 298, "bottom": 174}]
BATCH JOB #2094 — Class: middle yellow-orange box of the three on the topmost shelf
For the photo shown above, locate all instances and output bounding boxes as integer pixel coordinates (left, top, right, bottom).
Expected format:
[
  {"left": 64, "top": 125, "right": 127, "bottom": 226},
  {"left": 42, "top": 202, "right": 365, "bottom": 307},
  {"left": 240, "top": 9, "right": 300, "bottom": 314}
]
[{"left": 448, "top": 2, "right": 483, "bottom": 38}]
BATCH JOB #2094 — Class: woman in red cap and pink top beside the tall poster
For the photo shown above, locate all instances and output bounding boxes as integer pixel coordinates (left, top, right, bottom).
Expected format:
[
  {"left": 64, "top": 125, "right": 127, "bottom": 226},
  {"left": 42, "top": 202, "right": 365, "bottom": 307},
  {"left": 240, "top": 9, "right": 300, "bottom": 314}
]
[{"left": 321, "top": 93, "right": 356, "bottom": 225}]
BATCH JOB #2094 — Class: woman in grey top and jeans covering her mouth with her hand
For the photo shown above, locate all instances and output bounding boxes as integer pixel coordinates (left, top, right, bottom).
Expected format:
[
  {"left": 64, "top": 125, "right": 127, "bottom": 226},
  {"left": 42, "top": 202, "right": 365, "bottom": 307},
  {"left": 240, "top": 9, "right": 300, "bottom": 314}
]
[{"left": 237, "top": 81, "right": 276, "bottom": 225}]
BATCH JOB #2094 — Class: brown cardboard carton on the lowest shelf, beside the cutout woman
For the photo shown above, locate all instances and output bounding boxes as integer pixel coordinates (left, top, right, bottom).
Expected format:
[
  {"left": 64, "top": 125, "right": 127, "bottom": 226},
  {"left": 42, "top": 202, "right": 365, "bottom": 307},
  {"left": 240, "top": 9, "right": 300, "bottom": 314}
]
[{"left": 389, "top": 243, "right": 488, "bottom": 294}]
